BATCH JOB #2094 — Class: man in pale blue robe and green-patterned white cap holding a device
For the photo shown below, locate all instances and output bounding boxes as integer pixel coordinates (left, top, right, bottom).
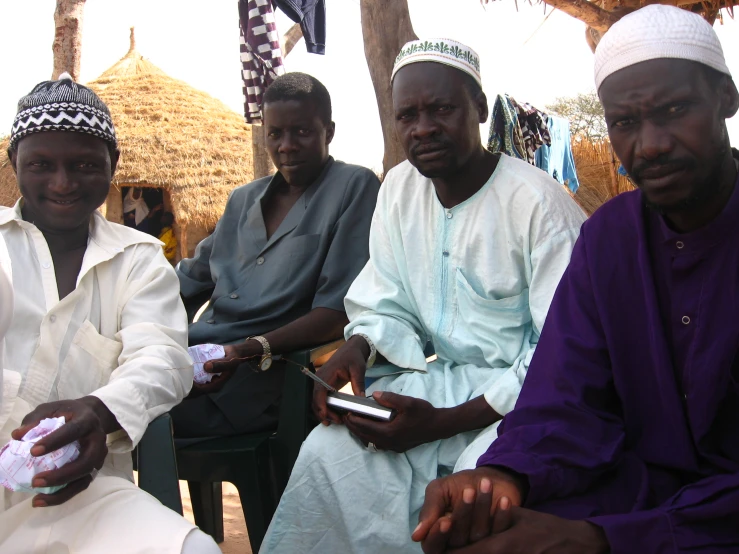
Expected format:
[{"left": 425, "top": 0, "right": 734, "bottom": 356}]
[{"left": 261, "top": 39, "right": 585, "bottom": 554}]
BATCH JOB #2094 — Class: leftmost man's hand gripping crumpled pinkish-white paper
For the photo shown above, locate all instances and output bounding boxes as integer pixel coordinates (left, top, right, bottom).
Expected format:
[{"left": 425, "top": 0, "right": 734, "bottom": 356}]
[{"left": 11, "top": 396, "right": 114, "bottom": 508}]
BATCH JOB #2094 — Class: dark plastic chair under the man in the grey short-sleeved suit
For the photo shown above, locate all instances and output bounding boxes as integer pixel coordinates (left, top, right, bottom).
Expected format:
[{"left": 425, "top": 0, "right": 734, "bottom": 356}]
[{"left": 176, "top": 340, "right": 343, "bottom": 552}]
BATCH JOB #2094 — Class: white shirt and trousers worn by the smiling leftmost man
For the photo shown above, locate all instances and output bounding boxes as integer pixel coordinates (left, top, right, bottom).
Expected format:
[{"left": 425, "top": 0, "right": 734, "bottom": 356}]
[{"left": 0, "top": 202, "right": 195, "bottom": 554}]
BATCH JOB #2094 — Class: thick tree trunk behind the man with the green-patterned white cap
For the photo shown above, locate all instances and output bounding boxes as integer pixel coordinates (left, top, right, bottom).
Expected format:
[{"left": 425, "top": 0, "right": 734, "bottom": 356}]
[{"left": 360, "top": 0, "right": 418, "bottom": 173}]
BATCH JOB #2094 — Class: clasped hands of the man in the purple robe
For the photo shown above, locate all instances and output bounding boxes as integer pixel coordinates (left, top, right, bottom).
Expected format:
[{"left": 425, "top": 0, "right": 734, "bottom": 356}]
[{"left": 412, "top": 467, "right": 609, "bottom": 554}]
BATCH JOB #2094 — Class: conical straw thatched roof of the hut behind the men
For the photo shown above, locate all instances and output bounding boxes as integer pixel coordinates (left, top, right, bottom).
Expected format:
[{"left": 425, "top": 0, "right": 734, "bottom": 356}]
[{"left": 0, "top": 30, "right": 253, "bottom": 227}]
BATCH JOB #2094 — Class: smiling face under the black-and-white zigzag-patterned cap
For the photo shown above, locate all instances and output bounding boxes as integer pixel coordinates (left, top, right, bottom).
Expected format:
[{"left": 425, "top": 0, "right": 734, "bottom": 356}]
[{"left": 10, "top": 131, "right": 118, "bottom": 232}]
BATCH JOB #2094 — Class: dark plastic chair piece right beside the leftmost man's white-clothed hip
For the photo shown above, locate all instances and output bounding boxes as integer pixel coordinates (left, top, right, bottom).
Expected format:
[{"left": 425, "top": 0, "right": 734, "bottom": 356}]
[{"left": 136, "top": 414, "right": 182, "bottom": 515}]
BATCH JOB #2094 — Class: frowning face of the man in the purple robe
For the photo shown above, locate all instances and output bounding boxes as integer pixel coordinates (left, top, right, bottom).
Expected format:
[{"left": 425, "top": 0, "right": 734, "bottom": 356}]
[{"left": 598, "top": 59, "right": 737, "bottom": 213}]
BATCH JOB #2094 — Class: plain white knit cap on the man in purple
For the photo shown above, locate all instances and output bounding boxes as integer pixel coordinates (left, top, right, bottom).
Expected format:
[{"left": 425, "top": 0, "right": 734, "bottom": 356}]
[{"left": 595, "top": 4, "right": 731, "bottom": 89}]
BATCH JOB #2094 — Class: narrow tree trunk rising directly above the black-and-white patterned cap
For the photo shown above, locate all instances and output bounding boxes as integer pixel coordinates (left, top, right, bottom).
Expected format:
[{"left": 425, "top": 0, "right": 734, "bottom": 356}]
[{"left": 51, "top": 0, "right": 85, "bottom": 81}]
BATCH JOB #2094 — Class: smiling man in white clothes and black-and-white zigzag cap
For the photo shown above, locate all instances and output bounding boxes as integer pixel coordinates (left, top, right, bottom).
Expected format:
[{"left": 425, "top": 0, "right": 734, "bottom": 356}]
[{"left": 0, "top": 74, "right": 219, "bottom": 554}]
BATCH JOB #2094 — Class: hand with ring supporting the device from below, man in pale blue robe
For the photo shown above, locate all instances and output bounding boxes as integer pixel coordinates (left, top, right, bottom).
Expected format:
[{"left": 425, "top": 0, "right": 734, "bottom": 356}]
[{"left": 344, "top": 392, "right": 443, "bottom": 452}]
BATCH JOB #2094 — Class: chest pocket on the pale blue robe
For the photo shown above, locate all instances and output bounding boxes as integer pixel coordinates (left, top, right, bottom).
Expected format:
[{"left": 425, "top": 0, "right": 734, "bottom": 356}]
[{"left": 455, "top": 270, "right": 531, "bottom": 367}]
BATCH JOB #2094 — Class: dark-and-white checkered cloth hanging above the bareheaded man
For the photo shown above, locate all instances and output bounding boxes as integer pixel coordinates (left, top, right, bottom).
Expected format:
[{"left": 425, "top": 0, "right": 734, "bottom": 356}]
[{"left": 239, "top": 0, "right": 285, "bottom": 124}]
